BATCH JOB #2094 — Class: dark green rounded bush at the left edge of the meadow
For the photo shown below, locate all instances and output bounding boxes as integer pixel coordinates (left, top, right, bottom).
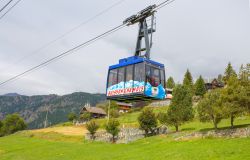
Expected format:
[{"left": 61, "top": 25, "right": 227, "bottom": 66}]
[{"left": 0, "top": 114, "right": 27, "bottom": 136}]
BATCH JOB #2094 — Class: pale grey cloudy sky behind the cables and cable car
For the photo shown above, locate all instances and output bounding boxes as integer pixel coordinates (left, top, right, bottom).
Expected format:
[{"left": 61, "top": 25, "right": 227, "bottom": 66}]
[{"left": 0, "top": 0, "right": 250, "bottom": 95}]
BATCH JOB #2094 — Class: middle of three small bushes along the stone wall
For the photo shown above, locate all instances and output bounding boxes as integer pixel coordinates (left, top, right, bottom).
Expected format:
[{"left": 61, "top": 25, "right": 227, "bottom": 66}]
[{"left": 105, "top": 119, "right": 120, "bottom": 143}]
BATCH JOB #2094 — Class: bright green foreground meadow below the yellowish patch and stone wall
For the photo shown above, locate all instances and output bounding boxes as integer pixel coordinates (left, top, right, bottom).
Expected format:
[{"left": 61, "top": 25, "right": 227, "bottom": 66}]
[{"left": 0, "top": 132, "right": 250, "bottom": 160}]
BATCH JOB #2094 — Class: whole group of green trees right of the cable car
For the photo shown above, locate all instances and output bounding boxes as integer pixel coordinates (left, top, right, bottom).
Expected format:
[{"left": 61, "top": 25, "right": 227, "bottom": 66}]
[{"left": 164, "top": 63, "right": 250, "bottom": 131}]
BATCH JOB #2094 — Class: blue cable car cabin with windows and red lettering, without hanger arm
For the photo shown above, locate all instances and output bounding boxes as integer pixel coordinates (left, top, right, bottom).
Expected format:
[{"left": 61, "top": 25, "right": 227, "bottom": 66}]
[{"left": 106, "top": 56, "right": 166, "bottom": 102}]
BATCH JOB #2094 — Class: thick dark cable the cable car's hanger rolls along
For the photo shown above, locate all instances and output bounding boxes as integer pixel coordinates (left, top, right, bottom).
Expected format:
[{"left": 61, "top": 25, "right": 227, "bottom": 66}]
[{"left": 0, "top": 0, "right": 174, "bottom": 86}]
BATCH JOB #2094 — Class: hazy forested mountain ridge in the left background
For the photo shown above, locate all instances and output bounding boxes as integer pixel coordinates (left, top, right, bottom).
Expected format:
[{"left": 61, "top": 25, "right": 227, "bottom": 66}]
[{"left": 0, "top": 92, "right": 106, "bottom": 128}]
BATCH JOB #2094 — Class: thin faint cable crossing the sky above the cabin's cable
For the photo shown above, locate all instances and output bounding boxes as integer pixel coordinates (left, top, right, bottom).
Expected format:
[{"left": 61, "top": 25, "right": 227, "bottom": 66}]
[{"left": 0, "top": 0, "right": 125, "bottom": 71}]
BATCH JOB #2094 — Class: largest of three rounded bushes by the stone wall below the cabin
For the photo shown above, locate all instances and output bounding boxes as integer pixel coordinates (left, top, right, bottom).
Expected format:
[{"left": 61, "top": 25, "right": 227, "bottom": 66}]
[{"left": 138, "top": 108, "right": 157, "bottom": 136}]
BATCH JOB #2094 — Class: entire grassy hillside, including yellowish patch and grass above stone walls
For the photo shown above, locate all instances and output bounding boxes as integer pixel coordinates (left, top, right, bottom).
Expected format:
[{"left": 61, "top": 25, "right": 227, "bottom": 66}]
[{"left": 0, "top": 108, "right": 250, "bottom": 160}]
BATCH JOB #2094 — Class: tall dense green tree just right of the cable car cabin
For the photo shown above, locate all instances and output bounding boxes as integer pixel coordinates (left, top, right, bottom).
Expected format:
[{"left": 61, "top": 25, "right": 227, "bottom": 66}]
[{"left": 167, "top": 85, "right": 194, "bottom": 131}]
